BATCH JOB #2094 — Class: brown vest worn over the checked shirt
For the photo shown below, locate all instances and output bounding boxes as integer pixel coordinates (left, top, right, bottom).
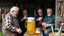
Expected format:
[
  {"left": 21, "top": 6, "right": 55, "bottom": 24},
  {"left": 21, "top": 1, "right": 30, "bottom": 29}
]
[{"left": 2, "top": 13, "right": 19, "bottom": 36}]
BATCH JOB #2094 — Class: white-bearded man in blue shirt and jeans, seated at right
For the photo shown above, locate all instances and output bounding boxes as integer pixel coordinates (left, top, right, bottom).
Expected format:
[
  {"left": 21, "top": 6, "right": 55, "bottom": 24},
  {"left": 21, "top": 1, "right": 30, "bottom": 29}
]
[{"left": 42, "top": 8, "right": 55, "bottom": 36}]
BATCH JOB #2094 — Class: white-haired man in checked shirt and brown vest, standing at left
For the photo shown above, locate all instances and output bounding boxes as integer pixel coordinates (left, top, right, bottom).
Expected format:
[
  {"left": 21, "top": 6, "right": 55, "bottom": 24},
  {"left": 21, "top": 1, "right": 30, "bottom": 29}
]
[{"left": 4, "top": 6, "right": 22, "bottom": 36}]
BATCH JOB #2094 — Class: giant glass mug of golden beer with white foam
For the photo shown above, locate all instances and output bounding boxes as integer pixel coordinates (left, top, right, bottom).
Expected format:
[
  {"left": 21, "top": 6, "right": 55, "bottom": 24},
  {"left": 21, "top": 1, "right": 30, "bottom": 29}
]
[{"left": 26, "top": 17, "right": 36, "bottom": 34}]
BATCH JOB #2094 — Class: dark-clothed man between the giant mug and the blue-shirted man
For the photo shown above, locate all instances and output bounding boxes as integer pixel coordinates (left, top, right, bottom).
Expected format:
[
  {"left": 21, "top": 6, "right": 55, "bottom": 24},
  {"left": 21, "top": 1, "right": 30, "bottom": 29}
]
[{"left": 35, "top": 9, "right": 43, "bottom": 27}]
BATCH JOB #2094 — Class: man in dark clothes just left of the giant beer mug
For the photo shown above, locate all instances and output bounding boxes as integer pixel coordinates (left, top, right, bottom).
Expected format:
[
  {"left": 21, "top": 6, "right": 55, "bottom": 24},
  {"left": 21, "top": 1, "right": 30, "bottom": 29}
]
[{"left": 19, "top": 9, "right": 28, "bottom": 36}]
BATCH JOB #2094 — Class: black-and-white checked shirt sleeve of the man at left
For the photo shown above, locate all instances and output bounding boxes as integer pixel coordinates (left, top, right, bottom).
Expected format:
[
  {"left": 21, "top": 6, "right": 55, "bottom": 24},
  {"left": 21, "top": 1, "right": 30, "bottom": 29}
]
[{"left": 4, "top": 13, "right": 16, "bottom": 32}]
